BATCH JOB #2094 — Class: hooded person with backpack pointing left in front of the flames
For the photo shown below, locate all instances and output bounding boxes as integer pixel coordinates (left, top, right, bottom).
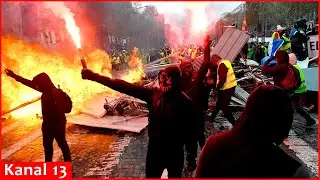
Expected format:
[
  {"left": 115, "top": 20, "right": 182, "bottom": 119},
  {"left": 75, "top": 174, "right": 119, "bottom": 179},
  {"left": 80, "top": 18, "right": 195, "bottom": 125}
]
[{"left": 5, "top": 69, "right": 72, "bottom": 162}]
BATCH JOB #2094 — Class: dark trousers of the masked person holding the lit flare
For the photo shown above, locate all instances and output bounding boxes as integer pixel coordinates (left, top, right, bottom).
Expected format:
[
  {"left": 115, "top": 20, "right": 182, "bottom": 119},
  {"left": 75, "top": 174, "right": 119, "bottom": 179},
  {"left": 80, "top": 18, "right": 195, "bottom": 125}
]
[{"left": 146, "top": 140, "right": 184, "bottom": 178}]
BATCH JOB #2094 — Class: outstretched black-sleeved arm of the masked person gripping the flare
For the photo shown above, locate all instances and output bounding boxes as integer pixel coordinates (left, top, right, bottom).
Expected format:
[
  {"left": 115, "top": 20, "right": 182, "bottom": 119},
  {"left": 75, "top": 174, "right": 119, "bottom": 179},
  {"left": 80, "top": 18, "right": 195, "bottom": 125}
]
[{"left": 81, "top": 69, "right": 152, "bottom": 102}]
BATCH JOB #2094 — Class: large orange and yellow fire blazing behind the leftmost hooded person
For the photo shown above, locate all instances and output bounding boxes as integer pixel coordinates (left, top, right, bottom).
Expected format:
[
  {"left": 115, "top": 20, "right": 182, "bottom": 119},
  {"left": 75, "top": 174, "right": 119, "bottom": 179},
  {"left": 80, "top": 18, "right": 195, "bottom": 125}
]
[{"left": 1, "top": 36, "right": 143, "bottom": 118}]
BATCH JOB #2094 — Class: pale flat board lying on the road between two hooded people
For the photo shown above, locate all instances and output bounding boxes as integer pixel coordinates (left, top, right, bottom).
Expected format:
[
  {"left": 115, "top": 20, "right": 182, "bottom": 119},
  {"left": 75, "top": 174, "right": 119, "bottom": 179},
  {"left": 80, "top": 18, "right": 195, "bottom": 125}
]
[{"left": 67, "top": 114, "right": 148, "bottom": 133}]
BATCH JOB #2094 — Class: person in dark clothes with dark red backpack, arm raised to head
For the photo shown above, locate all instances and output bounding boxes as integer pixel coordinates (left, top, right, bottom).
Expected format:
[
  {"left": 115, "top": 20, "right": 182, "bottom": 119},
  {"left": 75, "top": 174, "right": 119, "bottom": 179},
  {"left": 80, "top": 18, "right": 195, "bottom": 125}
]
[{"left": 262, "top": 50, "right": 316, "bottom": 126}]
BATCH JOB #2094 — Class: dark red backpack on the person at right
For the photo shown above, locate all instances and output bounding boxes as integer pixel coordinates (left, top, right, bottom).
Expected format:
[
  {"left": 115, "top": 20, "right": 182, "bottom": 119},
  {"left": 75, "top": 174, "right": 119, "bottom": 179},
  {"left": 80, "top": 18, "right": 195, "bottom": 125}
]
[{"left": 281, "top": 64, "right": 301, "bottom": 93}]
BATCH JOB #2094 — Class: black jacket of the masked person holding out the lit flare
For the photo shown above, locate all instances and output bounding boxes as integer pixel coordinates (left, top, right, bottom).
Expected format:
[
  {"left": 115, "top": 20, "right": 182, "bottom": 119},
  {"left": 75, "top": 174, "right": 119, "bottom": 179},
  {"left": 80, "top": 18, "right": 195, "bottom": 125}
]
[{"left": 88, "top": 67, "right": 195, "bottom": 147}]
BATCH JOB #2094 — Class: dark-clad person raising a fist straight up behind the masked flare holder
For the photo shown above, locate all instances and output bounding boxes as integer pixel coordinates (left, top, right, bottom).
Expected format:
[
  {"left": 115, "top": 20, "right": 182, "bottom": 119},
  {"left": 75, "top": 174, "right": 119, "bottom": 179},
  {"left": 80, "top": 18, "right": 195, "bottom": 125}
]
[{"left": 180, "top": 36, "right": 211, "bottom": 171}]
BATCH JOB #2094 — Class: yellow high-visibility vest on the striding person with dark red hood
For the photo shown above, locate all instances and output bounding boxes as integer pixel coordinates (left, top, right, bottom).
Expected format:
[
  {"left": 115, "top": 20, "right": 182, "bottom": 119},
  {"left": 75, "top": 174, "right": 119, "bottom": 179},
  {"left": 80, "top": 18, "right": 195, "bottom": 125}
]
[{"left": 217, "top": 60, "right": 237, "bottom": 90}]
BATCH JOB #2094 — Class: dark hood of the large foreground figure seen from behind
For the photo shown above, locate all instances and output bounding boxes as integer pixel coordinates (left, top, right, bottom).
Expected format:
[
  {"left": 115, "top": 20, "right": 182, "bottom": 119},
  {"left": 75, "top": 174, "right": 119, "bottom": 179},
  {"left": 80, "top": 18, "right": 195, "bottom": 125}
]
[{"left": 235, "top": 85, "right": 293, "bottom": 145}]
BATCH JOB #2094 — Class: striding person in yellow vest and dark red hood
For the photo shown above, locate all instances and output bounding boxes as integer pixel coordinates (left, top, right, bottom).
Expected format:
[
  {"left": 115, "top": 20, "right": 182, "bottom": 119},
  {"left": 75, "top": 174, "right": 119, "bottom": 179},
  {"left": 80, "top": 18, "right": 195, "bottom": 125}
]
[{"left": 210, "top": 54, "right": 237, "bottom": 125}]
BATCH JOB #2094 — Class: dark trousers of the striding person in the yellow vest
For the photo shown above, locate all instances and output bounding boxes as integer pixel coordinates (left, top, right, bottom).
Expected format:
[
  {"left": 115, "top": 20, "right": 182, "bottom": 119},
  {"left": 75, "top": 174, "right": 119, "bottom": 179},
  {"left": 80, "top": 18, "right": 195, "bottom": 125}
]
[{"left": 211, "top": 87, "right": 236, "bottom": 125}]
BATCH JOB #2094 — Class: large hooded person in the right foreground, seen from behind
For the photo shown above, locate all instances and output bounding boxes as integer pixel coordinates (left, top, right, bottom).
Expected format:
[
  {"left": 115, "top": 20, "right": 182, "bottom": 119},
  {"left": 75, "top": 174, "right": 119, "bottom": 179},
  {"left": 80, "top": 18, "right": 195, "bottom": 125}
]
[{"left": 196, "top": 85, "right": 309, "bottom": 178}]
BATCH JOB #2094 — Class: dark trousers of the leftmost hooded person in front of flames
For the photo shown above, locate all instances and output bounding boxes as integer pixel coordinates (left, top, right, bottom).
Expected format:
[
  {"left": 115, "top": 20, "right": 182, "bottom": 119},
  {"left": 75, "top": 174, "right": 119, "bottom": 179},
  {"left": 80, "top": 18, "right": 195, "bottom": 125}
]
[{"left": 42, "top": 125, "right": 71, "bottom": 162}]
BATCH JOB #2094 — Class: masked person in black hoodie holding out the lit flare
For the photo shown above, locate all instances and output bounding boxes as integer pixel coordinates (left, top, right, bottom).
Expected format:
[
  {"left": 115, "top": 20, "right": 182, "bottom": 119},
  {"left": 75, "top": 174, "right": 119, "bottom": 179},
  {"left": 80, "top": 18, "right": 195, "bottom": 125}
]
[{"left": 82, "top": 66, "right": 195, "bottom": 178}]
